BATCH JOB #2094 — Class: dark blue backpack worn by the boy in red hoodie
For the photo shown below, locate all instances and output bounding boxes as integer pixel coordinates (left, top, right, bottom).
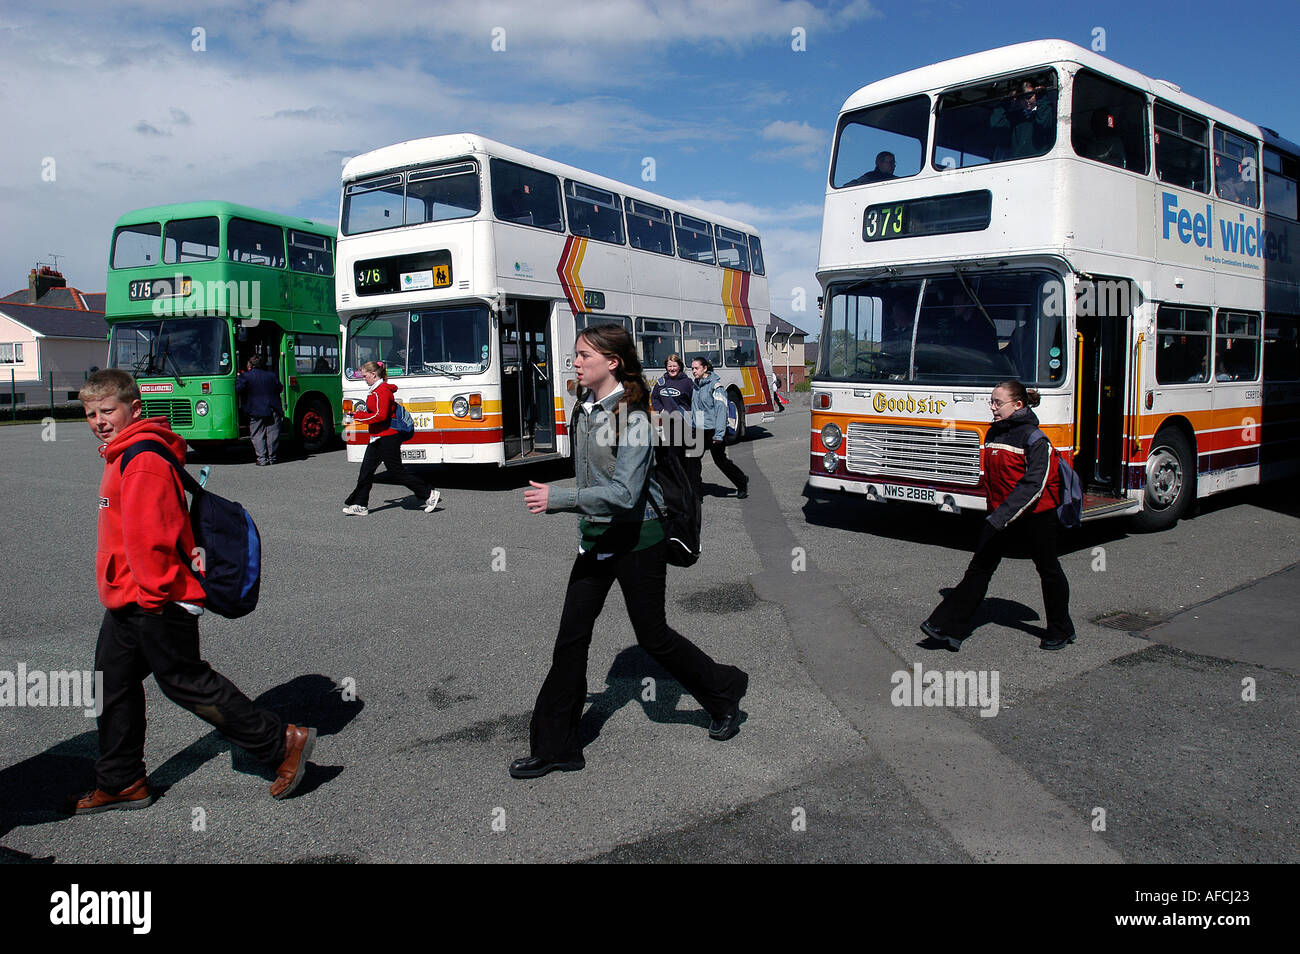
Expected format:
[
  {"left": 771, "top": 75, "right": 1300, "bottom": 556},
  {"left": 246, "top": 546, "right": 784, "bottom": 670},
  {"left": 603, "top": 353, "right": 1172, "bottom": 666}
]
[{"left": 120, "top": 441, "right": 261, "bottom": 620}]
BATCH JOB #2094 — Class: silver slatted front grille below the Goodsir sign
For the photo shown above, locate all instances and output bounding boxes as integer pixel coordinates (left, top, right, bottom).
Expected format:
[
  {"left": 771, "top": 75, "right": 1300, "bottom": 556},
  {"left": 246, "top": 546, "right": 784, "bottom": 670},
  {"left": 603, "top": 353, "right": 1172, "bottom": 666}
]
[{"left": 845, "top": 424, "right": 979, "bottom": 486}]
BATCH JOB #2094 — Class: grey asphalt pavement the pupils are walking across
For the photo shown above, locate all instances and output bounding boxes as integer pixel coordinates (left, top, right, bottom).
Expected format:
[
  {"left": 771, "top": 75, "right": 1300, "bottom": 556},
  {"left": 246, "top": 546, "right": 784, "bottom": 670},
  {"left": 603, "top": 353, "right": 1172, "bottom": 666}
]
[{"left": 0, "top": 407, "right": 1300, "bottom": 862}]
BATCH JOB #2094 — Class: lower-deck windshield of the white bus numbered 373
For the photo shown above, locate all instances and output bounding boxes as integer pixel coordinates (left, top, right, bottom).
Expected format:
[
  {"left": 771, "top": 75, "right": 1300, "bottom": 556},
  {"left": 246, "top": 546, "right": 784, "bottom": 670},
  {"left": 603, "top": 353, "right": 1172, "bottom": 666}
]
[{"left": 818, "top": 269, "right": 1066, "bottom": 387}]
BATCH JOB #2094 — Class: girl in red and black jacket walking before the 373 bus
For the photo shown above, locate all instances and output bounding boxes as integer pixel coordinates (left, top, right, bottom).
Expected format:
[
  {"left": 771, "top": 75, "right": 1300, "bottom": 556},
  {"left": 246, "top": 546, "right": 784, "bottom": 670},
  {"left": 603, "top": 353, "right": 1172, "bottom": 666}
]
[{"left": 920, "top": 381, "right": 1074, "bottom": 652}]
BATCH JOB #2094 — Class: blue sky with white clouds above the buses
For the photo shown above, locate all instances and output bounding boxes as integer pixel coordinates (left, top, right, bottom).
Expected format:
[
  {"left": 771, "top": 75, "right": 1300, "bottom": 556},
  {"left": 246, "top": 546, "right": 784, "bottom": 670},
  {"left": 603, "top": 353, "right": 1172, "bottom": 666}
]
[{"left": 0, "top": 0, "right": 1300, "bottom": 330}]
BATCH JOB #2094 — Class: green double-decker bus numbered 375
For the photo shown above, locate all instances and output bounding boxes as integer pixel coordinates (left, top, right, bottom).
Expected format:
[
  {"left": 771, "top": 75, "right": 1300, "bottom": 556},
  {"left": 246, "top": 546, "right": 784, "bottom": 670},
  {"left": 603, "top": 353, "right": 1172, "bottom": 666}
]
[{"left": 105, "top": 201, "right": 342, "bottom": 452}]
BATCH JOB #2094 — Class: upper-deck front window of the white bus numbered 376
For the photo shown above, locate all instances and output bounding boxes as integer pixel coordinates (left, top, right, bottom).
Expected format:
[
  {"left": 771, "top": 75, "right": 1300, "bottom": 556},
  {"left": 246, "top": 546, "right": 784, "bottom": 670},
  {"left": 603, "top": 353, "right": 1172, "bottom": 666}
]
[{"left": 342, "top": 162, "right": 480, "bottom": 235}]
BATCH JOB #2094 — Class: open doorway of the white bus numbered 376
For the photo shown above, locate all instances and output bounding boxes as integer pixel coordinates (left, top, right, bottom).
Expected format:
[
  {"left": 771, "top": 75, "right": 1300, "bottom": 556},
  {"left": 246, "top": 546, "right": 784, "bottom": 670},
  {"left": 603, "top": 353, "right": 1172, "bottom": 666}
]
[{"left": 501, "top": 299, "right": 556, "bottom": 463}]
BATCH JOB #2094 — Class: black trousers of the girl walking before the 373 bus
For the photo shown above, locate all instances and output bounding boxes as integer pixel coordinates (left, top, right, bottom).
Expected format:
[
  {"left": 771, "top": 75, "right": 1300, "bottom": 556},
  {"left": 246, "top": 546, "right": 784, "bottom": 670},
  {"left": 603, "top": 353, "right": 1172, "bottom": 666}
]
[{"left": 928, "top": 509, "right": 1074, "bottom": 639}]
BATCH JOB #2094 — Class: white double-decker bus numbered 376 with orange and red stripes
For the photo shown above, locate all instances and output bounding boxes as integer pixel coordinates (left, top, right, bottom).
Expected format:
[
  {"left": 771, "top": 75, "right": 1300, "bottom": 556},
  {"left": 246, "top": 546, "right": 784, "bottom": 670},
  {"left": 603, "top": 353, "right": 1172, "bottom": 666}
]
[{"left": 337, "top": 134, "right": 772, "bottom": 464}]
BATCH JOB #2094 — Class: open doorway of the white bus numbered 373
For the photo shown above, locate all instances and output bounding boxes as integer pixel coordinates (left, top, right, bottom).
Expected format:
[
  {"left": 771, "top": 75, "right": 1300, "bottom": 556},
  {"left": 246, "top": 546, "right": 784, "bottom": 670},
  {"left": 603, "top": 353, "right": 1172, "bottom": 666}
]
[{"left": 1074, "top": 277, "right": 1136, "bottom": 498}]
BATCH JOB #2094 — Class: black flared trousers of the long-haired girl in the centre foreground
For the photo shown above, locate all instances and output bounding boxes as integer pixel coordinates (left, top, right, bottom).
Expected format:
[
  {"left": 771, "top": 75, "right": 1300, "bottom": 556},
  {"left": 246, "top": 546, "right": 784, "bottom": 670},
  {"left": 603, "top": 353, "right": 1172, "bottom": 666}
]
[{"left": 530, "top": 540, "right": 745, "bottom": 762}]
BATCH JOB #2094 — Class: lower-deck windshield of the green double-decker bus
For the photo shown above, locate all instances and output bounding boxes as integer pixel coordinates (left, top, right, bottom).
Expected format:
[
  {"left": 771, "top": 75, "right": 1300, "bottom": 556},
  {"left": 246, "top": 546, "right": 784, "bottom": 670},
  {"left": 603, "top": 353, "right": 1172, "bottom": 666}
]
[{"left": 108, "top": 317, "right": 233, "bottom": 377}]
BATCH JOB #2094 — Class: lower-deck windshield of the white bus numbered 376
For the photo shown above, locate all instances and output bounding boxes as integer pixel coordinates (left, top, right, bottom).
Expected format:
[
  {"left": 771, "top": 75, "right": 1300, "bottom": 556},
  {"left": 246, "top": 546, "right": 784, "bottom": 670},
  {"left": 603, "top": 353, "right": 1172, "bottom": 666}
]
[{"left": 346, "top": 304, "right": 491, "bottom": 381}]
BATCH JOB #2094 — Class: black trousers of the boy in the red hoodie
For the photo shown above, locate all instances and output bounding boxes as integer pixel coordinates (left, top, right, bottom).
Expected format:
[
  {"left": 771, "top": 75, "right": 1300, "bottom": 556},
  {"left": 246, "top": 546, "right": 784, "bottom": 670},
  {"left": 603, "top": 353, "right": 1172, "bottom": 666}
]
[{"left": 95, "top": 603, "right": 285, "bottom": 794}]
